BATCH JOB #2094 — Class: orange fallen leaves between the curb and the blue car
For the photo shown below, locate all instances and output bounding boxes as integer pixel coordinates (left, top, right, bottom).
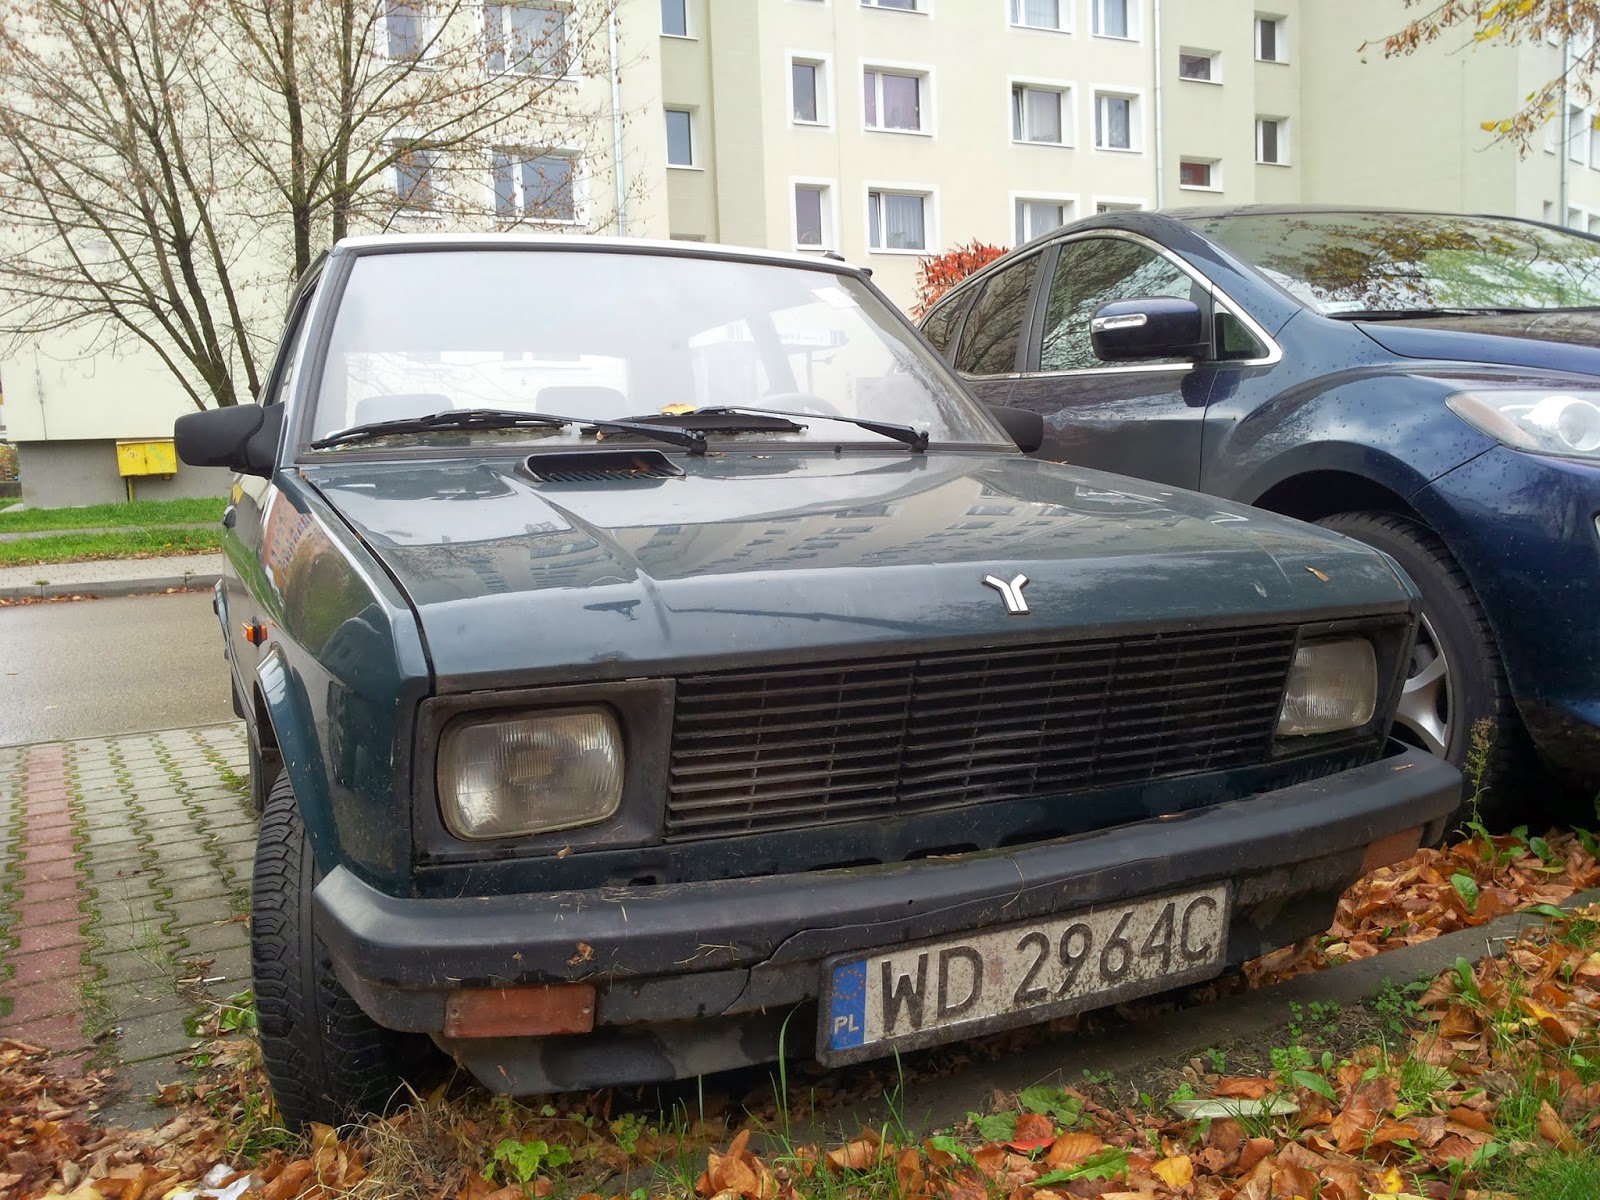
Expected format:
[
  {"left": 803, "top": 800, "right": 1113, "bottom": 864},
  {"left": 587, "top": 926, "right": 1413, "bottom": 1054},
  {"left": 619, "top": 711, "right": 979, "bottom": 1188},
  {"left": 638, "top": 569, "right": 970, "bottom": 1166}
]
[{"left": 1245, "top": 832, "right": 1600, "bottom": 987}]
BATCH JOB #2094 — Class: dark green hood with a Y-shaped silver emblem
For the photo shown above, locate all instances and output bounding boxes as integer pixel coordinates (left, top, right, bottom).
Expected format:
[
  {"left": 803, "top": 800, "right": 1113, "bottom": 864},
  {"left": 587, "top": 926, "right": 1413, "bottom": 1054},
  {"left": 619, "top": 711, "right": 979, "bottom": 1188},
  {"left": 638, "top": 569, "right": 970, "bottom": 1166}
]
[{"left": 304, "top": 451, "right": 1411, "bottom": 691}]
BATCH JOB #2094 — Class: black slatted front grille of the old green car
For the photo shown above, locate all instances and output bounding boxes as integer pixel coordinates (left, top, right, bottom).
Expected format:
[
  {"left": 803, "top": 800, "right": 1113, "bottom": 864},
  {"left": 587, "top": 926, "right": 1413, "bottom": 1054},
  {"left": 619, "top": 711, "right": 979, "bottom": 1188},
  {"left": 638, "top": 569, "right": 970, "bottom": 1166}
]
[{"left": 666, "top": 627, "right": 1294, "bottom": 842}]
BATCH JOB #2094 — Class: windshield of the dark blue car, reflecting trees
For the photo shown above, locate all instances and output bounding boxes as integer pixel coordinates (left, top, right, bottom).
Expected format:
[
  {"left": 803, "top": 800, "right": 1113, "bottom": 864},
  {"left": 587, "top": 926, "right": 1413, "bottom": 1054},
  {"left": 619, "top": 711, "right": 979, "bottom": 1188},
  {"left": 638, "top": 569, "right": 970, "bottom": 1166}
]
[{"left": 1190, "top": 213, "right": 1600, "bottom": 315}]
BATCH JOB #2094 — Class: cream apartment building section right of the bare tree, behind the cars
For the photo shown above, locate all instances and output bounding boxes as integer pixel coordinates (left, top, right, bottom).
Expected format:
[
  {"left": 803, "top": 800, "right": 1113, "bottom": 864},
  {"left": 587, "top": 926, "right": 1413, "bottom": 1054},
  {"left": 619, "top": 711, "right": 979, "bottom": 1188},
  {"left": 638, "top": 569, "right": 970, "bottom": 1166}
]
[{"left": 659, "top": 0, "right": 1600, "bottom": 302}]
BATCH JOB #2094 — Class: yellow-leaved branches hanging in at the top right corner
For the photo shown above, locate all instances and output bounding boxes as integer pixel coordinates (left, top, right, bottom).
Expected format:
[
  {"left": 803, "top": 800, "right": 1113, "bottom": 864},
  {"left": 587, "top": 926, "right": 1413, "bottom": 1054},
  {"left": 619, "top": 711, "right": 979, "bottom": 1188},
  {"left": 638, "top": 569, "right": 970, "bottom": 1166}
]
[{"left": 1362, "top": 0, "right": 1600, "bottom": 154}]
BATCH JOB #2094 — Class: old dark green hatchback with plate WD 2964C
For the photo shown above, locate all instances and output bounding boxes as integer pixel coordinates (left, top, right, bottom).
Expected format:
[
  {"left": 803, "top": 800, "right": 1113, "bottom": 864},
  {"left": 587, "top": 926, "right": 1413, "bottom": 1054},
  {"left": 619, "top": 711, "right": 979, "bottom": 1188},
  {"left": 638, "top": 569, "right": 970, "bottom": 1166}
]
[{"left": 176, "top": 237, "right": 1459, "bottom": 1122}]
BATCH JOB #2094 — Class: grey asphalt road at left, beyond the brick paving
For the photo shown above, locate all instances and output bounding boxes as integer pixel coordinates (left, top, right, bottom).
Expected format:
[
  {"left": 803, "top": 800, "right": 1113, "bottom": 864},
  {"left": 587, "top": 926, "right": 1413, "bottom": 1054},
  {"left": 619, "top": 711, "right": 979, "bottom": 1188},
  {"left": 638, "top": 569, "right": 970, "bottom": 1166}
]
[{"left": 0, "top": 592, "right": 234, "bottom": 746}]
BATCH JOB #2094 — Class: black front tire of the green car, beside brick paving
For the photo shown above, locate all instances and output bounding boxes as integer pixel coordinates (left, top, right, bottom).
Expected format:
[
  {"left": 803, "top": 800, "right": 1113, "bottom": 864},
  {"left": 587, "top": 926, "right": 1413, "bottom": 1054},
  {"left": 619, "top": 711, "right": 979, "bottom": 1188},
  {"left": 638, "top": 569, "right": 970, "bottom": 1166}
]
[{"left": 250, "top": 773, "right": 442, "bottom": 1130}]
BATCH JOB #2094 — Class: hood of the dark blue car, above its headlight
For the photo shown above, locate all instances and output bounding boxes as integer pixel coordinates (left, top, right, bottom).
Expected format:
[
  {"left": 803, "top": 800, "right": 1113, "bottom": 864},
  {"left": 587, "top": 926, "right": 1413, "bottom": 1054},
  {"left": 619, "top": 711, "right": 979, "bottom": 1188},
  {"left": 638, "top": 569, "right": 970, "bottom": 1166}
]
[{"left": 1357, "top": 312, "right": 1600, "bottom": 374}]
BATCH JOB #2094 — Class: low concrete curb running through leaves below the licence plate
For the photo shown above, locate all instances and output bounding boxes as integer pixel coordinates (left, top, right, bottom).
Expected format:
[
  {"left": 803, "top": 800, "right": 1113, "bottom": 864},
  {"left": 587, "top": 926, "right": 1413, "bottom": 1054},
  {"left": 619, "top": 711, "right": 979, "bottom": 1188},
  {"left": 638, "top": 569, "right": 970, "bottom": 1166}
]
[{"left": 790, "top": 890, "right": 1600, "bottom": 1144}]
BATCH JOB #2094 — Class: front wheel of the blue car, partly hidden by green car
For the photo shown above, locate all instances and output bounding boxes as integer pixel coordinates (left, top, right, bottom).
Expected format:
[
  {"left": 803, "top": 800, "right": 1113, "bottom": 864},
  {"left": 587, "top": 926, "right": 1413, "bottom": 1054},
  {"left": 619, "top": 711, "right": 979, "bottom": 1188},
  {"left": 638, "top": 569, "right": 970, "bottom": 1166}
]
[{"left": 1317, "top": 512, "right": 1528, "bottom": 821}]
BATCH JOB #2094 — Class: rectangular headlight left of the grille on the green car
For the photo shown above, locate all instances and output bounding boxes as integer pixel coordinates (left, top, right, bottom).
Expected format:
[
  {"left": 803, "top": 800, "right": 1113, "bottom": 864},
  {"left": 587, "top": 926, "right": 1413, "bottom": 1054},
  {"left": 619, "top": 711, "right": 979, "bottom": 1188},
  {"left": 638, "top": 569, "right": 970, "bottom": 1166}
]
[{"left": 438, "top": 709, "right": 622, "bottom": 838}]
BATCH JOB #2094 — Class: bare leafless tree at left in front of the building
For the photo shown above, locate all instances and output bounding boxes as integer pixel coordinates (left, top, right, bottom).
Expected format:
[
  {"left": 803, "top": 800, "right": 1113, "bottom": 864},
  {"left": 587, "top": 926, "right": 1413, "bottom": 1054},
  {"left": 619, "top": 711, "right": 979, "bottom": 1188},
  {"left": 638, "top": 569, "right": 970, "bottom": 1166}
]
[{"left": 0, "top": 0, "right": 636, "bottom": 406}]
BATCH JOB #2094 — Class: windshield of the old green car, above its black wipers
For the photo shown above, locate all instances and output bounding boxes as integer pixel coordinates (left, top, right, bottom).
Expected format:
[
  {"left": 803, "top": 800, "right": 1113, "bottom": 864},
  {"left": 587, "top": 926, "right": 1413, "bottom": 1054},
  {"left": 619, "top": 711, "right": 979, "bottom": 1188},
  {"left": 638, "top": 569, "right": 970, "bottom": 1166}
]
[{"left": 312, "top": 248, "right": 1010, "bottom": 453}]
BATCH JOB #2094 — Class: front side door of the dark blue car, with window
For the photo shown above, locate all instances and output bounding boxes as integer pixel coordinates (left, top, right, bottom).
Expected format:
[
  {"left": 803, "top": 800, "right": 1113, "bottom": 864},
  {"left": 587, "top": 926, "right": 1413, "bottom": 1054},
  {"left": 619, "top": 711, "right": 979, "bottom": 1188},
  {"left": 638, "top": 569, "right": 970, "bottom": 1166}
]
[{"left": 1004, "top": 232, "right": 1216, "bottom": 488}]
